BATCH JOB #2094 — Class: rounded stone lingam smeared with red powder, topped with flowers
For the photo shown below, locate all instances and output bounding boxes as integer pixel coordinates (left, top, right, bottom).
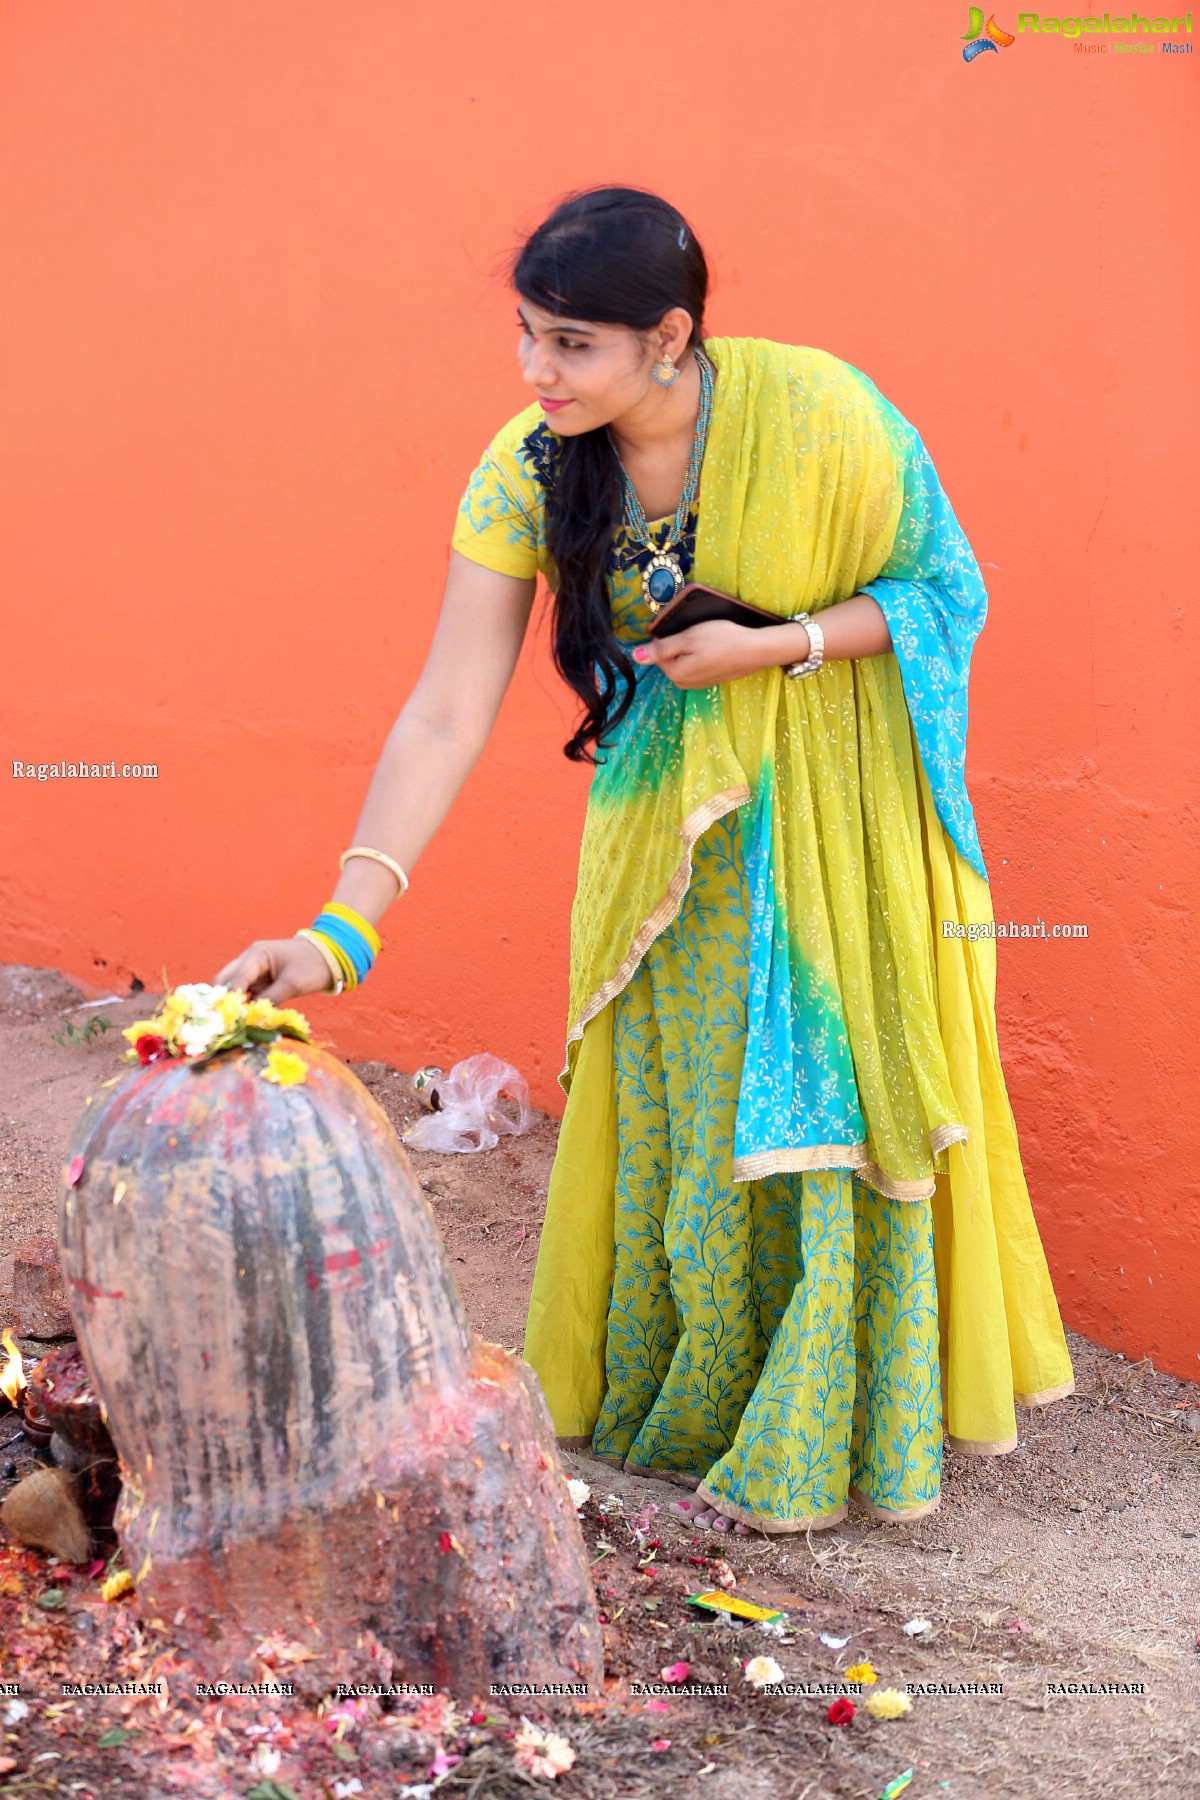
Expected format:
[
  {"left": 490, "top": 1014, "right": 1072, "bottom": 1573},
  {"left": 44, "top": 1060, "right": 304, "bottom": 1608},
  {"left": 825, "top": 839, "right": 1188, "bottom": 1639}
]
[{"left": 59, "top": 986, "right": 603, "bottom": 1696}]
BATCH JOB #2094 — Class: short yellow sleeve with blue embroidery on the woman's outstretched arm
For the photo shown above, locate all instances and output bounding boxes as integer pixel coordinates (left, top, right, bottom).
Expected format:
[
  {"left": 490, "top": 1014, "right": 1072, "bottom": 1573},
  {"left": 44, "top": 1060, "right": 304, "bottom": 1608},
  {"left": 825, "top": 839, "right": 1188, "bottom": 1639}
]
[{"left": 450, "top": 405, "right": 545, "bottom": 576}]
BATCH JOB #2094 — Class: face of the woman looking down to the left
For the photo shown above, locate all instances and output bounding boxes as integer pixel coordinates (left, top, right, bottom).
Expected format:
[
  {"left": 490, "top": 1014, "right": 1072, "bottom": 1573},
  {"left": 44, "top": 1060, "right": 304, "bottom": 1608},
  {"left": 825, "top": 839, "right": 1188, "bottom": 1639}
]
[{"left": 516, "top": 297, "right": 691, "bottom": 437}]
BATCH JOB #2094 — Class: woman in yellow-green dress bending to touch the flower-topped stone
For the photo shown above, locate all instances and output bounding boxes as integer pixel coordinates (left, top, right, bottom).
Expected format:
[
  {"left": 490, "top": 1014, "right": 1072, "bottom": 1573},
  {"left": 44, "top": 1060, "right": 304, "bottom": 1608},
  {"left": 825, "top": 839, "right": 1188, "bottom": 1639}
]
[{"left": 218, "top": 187, "right": 1074, "bottom": 1534}]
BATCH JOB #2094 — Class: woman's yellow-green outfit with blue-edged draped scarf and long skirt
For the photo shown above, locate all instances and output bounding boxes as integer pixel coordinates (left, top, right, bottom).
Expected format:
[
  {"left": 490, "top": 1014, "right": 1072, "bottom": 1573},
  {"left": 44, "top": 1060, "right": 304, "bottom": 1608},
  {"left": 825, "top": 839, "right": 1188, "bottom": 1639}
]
[{"left": 452, "top": 337, "right": 1074, "bottom": 1532}]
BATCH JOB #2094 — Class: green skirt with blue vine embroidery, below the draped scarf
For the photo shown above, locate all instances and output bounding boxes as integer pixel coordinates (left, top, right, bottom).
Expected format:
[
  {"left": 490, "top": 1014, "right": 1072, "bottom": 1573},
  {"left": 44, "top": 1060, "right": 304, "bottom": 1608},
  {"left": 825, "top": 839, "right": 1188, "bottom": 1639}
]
[{"left": 525, "top": 814, "right": 943, "bottom": 1532}]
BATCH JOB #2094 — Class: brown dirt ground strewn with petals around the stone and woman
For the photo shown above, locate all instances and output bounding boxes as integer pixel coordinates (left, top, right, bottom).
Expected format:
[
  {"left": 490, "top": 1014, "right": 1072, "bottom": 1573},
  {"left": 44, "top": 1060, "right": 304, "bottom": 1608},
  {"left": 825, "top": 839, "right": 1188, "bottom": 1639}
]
[{"left": 0, "top": 968, "right": 1200, "bottom": 1800}]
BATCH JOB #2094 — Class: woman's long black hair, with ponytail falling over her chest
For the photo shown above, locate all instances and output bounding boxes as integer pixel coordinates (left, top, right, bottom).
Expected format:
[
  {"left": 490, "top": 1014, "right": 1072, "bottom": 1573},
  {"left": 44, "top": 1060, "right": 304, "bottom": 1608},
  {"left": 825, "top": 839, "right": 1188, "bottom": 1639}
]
[{"left": 509, "top": 187, "right": 709, "bottom": 763}]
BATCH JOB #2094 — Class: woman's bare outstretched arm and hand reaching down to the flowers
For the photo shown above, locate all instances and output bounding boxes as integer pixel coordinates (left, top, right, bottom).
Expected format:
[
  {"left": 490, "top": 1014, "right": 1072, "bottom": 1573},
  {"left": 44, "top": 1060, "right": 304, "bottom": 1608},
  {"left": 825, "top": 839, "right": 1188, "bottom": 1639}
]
[{"left": 214, "top": 549, "right": 536, "bottom": 1001}]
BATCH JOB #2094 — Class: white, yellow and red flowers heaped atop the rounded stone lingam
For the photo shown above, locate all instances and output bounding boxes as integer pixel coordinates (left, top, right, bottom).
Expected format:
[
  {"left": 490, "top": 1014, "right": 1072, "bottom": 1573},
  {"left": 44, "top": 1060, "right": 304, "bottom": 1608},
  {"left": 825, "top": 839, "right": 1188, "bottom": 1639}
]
[{"left": 121, "top": 981, "right": 313, "bottom": 1087}]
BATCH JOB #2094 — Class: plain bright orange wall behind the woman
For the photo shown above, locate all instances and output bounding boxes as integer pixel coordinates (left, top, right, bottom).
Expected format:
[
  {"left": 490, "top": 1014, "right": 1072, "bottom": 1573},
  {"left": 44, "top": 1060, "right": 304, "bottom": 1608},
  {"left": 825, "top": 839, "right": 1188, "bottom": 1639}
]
[{"left": 0, "top": 0, "right": 1200, "bottom": 1377}]
